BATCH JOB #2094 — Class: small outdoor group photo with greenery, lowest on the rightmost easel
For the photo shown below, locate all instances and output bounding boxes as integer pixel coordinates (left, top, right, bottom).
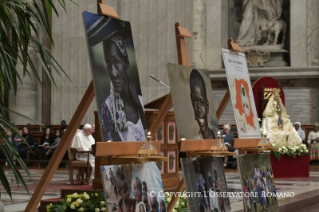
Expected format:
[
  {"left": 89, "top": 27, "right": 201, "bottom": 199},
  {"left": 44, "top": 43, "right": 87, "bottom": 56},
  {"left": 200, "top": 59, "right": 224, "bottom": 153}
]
[{"left": 238, "top": 154, "right": 278, "bottom": 212}]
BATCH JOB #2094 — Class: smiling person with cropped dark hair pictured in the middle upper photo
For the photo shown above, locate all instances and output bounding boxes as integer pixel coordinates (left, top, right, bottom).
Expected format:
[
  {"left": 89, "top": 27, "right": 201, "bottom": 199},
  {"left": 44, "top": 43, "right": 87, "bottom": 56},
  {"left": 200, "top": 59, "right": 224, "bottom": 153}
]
[{"left": 190, "top": 69, "right": 216, "bottom": 139}]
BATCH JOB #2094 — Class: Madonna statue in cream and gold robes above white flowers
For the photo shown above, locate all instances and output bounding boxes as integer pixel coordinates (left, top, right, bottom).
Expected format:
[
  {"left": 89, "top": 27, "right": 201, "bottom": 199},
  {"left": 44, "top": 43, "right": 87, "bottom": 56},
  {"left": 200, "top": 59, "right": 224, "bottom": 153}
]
[{"left": 262, "top": 89, "right": 302, "bottom": 146}]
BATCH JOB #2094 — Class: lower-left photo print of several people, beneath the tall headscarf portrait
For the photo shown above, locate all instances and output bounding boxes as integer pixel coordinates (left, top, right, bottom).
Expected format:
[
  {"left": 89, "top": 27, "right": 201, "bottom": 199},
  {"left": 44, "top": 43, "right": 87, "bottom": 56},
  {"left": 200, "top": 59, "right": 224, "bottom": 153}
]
[{"left": 101, "top": 162, "right": 166, "bottom": 212}]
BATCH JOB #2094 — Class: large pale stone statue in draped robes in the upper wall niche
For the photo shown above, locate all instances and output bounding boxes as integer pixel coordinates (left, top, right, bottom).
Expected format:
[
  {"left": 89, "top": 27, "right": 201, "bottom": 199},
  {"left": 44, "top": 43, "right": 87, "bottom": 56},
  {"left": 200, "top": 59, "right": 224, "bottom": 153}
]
[{"left": 236, "top": 0, "right": 286, "bottom": 46}]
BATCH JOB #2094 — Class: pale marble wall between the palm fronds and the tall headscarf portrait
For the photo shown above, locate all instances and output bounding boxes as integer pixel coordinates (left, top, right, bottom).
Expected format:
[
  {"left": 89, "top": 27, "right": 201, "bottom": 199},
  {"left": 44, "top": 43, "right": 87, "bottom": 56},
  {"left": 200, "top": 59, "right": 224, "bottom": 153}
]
[{"left": 51, "top": 0, "right": 96, "bottom": 124}]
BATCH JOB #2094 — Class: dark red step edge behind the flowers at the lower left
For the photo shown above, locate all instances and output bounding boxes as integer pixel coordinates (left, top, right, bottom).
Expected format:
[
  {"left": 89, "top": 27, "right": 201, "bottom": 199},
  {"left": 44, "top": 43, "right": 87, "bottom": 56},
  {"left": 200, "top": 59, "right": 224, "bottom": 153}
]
[{"left": 38, "top": 185, "right": 101, "bottom": 212}]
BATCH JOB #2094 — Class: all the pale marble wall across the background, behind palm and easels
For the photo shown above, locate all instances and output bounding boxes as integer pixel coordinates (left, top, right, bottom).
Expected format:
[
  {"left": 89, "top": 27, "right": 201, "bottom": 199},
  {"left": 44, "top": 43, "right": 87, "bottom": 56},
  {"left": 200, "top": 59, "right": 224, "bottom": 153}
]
[{"left": 10, "top": 0, "right": 319, "bottom": 124}]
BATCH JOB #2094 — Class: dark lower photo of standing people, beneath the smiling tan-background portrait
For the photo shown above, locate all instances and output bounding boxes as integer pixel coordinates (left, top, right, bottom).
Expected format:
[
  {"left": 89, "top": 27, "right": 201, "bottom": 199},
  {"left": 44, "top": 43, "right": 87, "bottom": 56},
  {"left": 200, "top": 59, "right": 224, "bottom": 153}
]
[{"left": 181, "top": 157, "right": 231, "bottom": 212}]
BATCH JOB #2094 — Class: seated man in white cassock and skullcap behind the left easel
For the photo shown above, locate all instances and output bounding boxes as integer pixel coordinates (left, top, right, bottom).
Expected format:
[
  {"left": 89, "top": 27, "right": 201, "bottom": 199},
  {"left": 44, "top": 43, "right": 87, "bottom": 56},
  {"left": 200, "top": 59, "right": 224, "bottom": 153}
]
[{"left": 71, "top": 124, "right": 95, "bottom": 183}]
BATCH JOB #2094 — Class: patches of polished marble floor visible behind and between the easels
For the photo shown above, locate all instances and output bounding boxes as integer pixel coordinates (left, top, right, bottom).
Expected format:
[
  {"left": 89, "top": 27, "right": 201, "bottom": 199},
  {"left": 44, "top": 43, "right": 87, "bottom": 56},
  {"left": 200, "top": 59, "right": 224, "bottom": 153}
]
[{"left": 0, "top": 169, "right": 319, "bottom": 212}]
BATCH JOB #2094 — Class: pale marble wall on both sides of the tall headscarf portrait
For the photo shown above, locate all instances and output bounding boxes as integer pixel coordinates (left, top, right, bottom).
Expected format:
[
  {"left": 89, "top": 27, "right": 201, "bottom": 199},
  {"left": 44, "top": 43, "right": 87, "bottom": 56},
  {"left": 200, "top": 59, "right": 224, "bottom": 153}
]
[{"left": 51, "top": 0, "right": 193, "bottom": 124}]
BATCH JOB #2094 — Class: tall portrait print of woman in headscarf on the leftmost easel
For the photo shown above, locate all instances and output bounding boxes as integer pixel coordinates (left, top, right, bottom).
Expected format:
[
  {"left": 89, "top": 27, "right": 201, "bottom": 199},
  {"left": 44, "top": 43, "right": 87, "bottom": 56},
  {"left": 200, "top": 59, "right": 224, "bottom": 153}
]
[{"left": 83, "top": 12, "right": 147, "bottom": 141}]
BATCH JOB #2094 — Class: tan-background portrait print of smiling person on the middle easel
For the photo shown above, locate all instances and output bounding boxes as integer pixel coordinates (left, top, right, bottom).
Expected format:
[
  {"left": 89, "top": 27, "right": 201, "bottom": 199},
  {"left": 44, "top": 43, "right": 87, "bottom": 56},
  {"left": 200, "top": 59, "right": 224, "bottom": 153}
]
[{"left": 167, "top": 63, "right": 218, "bottom": 139}]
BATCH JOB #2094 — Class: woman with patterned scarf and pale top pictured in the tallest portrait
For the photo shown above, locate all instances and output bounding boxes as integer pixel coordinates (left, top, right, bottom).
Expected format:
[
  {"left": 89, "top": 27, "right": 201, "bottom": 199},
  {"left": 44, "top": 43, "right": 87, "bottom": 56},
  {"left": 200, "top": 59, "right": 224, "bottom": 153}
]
[{"left": 100, "top": 34, "right": 147, "bottom": 141}]
